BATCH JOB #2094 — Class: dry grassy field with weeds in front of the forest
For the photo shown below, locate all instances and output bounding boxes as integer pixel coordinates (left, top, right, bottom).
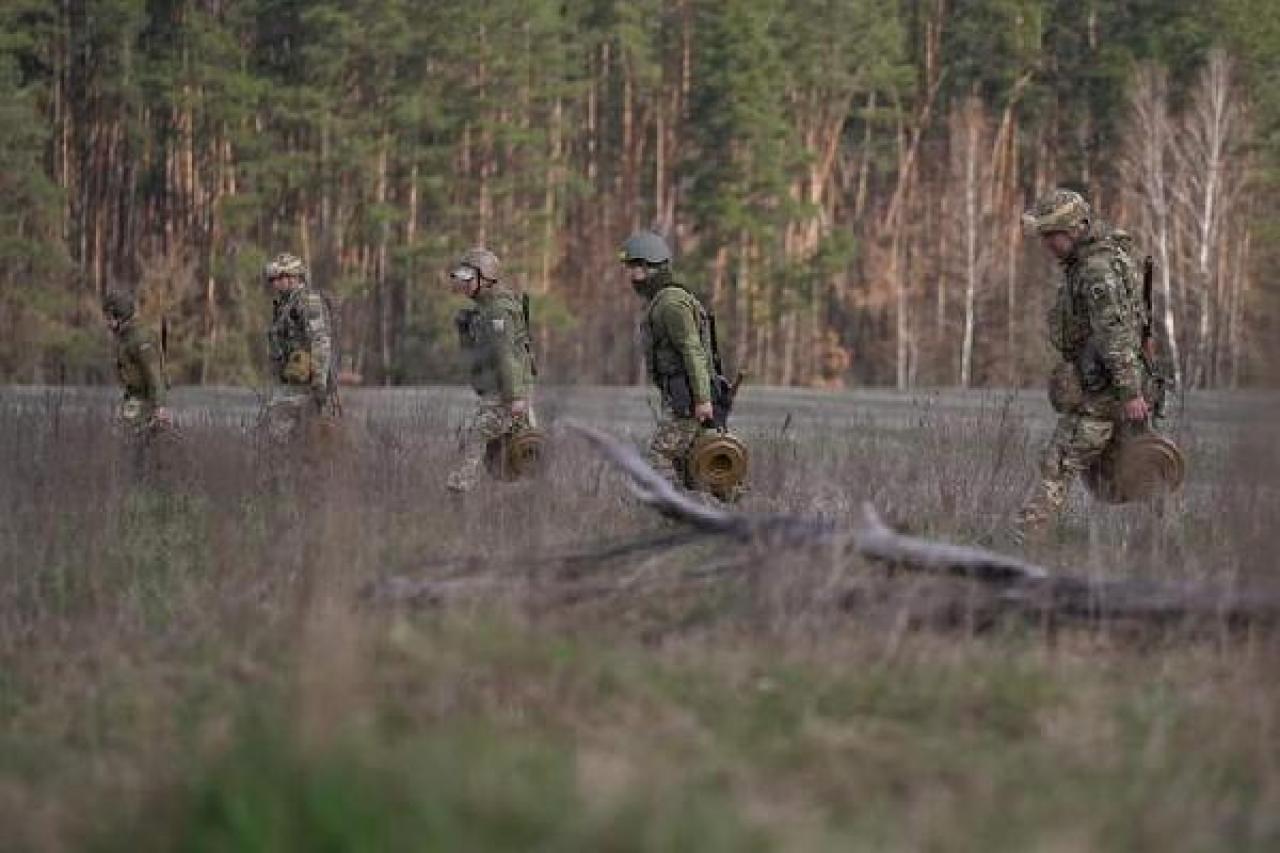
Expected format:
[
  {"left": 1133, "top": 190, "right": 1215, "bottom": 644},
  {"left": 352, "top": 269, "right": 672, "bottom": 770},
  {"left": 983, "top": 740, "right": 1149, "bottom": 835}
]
[{"left": 0, "top": 389, "right": 1280, "bottom": 852}]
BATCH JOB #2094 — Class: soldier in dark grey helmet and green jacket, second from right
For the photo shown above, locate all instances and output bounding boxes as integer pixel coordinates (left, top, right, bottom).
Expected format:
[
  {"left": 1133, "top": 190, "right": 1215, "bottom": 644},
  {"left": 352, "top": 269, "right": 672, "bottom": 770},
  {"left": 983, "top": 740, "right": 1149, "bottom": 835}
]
[{"left": 620, "top": 231, "right": 714, "bottom": 487}]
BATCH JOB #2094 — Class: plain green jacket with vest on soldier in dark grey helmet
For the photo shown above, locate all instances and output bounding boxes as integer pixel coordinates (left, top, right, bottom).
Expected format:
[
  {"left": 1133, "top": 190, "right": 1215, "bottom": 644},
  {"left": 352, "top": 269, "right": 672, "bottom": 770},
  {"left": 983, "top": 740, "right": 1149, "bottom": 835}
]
[{"left": 640, "top": 268, "right": 714, "bottom": 409}]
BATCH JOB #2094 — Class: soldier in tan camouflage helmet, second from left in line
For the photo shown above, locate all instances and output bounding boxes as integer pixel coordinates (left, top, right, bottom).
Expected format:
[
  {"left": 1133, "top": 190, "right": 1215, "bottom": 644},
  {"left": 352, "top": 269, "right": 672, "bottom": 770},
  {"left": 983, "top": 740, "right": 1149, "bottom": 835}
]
[{"left": 262, "top": 252, "right": 337, "bottom": 441}]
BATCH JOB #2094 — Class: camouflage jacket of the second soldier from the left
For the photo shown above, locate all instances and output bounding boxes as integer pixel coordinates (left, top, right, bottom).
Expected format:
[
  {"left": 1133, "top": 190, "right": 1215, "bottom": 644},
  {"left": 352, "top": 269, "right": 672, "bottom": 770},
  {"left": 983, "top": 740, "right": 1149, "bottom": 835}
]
[{"left": 266, "top": 287, "right": 333, "bottom": 392}]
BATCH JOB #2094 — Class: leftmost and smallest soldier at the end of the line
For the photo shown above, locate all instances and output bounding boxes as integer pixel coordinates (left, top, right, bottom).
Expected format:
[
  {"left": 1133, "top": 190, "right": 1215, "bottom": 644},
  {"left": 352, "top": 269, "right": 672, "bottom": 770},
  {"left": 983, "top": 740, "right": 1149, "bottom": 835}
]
[{"left": 102, "top": 291, "right": 173, "bottom": 435}]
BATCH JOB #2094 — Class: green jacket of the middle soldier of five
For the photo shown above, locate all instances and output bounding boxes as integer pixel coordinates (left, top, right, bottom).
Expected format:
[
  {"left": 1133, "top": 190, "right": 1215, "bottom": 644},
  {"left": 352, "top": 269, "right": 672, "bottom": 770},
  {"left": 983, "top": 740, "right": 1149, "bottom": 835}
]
[{"left": 456, "top": 284, "right": 534, "bottom": 402}]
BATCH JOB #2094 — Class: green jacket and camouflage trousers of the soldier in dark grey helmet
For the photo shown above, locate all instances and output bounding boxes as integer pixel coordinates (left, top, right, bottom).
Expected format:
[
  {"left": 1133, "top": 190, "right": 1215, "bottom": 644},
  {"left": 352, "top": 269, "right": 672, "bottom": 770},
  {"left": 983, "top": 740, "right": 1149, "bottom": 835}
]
[{"left": 640, "top": 270, "right": 713, "bottom": 485}]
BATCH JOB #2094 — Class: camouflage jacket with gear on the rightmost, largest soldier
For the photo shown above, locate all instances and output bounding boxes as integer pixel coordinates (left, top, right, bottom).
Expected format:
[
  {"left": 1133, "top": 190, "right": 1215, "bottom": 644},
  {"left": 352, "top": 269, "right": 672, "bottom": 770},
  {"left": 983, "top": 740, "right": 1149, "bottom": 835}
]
[{"left": 1048, "top": 229, "right": 1146, "bottom": 401}]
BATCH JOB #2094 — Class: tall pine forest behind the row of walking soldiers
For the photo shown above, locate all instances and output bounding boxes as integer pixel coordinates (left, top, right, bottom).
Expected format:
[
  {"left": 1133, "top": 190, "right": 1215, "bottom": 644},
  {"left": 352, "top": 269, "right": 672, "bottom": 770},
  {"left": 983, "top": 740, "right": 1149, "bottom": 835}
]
[{"left": 0, "top": 0, "right": 1280, "bottom": 389}]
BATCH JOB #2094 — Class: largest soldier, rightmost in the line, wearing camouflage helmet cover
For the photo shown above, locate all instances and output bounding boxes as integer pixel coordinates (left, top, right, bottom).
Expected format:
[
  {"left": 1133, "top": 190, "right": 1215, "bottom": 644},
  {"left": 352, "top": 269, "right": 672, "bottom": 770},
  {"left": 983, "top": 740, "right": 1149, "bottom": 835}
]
[{"left": 1016, "top": 190, "right": 1151, "bottom": 534}]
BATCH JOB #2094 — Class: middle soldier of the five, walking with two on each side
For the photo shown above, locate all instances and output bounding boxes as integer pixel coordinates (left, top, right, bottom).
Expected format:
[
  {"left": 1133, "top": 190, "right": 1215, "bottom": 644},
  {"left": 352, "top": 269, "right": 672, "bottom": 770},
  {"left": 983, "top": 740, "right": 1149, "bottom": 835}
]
[{"left": 445, "top": 247, "right": 534, "bottom": 493}]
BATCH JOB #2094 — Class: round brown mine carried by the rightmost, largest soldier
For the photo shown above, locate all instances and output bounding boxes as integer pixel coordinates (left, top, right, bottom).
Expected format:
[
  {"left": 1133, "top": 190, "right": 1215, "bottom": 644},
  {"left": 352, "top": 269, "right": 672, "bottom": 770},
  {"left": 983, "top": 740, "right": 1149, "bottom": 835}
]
[{"left": 1084, "top": 429, "right": 1187, "bottom": 503}]
